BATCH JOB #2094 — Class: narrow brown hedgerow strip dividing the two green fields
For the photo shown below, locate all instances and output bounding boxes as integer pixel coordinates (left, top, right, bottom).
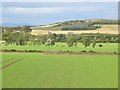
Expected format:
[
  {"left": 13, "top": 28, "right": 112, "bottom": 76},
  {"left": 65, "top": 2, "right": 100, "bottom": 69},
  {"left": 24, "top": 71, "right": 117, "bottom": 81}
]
[{"left": 0, "top": 50, "right": 120, "bottom": 55}]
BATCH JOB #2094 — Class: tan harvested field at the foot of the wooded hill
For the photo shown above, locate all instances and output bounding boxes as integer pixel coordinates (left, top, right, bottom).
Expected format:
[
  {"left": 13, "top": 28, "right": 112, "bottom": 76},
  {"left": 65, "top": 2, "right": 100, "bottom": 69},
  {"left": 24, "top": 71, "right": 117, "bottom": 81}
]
[{"left": 31, "top": 25, "right": 118, "bottom": 35}]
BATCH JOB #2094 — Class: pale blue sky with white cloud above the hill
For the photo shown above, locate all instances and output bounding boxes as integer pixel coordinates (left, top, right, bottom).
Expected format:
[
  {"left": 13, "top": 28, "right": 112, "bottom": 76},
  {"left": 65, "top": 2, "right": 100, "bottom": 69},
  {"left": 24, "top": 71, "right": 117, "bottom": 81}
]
[{"left": 0, "top": 2, "right": 118, "bottom": 26}]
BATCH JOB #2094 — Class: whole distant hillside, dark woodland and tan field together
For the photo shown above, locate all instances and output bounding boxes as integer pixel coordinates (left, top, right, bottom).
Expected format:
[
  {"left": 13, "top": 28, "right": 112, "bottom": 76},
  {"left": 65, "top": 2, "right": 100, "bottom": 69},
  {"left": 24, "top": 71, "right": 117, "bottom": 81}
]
[{"left": 31, "top": 19, "right": 118, "bottom": 35}]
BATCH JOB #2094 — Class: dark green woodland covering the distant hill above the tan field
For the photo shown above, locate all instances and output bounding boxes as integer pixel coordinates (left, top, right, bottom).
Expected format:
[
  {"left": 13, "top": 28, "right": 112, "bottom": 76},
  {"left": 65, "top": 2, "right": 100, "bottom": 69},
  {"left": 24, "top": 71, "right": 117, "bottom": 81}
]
[{"left": 56, "top": 19, "right": 119, "bottom": 30}]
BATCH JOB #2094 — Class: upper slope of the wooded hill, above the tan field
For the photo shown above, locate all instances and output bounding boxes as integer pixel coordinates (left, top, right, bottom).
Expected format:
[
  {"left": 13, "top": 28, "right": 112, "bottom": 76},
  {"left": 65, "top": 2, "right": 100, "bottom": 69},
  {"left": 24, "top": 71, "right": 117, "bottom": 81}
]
[{"left": 31, "top": 19, "right": 118, "bottom": 31}]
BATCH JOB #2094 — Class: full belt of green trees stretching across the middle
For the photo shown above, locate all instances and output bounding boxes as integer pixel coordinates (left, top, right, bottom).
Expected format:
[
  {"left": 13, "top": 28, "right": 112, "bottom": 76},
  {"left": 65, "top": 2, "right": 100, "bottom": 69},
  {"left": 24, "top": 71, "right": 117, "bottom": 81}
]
[{"left": 2, "top": 26, "right": 120, "bottom": 48}]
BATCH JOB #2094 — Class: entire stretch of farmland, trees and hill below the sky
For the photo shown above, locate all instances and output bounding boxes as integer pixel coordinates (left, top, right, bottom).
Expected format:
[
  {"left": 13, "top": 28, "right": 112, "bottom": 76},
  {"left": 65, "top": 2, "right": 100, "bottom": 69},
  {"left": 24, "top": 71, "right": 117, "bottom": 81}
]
[{"left": 0, "top": 19, "right": 120, "bottom": 88}]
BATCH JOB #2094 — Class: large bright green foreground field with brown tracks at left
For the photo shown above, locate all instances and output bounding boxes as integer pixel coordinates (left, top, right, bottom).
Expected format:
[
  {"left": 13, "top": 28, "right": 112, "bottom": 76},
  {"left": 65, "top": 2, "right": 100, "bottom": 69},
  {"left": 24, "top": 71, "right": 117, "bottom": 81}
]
[{"left": 2, "top": 53, "right": 118, "bottom": 88}]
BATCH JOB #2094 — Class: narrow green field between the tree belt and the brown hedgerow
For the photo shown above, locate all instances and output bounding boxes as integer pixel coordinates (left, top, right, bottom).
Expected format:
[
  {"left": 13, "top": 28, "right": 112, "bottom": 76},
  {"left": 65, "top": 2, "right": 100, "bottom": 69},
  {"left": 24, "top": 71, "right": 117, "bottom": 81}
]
[{"left": 2, "top": 43, "right": 118, "bottom": 53}]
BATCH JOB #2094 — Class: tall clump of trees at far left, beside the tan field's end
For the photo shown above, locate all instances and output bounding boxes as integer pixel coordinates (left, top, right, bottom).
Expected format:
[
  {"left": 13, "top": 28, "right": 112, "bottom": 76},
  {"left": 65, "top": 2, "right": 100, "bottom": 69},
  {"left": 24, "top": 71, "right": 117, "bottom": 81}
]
[{"left": 2, "top": 26, "right": 32, "bottom": 45}]
